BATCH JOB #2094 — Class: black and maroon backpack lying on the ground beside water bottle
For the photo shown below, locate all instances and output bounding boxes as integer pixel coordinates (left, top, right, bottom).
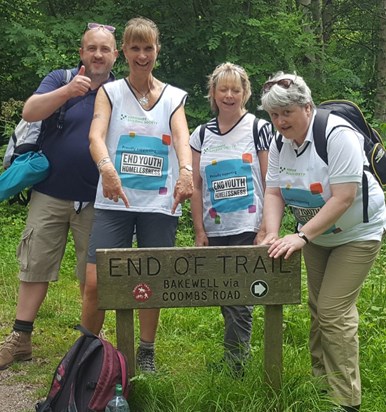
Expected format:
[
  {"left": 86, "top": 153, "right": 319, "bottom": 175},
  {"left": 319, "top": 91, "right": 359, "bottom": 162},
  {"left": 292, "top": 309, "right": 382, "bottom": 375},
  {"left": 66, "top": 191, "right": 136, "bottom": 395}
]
[{"left": 35, "top": 325, "right": 130, "bottom": 412}]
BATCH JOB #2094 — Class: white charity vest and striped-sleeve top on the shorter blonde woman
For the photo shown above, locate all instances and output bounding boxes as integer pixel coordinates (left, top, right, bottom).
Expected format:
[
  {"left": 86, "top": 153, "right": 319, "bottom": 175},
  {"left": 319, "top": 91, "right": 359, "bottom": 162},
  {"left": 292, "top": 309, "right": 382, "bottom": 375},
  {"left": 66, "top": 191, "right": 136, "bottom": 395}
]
[{"left": 190, "top": 113, "right": 272, "bottom": 237}]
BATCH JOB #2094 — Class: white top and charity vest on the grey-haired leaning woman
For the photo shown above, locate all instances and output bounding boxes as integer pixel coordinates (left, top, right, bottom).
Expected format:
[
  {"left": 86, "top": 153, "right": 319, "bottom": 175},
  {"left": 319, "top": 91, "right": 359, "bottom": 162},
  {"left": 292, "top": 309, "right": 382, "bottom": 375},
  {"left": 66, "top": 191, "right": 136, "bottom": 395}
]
[{"left": 266, "top": 109, "right": 386, "bottom": 246}]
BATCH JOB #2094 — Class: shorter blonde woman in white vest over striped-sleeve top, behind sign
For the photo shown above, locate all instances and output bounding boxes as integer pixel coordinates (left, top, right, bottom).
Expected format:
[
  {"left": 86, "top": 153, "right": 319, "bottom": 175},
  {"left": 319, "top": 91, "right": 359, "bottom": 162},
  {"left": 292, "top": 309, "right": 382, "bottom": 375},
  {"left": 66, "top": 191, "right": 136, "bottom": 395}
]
[{"left": 190, "top": 63, "right": 272, "bottom": 376}]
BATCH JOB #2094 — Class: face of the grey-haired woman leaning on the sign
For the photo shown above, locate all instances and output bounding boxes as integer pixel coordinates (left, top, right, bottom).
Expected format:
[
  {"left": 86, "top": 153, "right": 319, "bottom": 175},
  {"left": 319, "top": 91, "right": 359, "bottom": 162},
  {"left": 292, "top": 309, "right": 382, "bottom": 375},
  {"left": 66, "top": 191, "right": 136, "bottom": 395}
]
[{"left": 268, "top": 104, "right": 312, "bottom": 146}]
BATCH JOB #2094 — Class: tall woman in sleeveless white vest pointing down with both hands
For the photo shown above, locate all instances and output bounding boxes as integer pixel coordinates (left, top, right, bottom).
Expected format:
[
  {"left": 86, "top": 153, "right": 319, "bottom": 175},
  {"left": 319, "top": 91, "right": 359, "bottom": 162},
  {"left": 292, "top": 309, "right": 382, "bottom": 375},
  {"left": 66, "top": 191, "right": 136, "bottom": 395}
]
[{"left": 82, "top": 18, "right": 193, "bottom": 372}]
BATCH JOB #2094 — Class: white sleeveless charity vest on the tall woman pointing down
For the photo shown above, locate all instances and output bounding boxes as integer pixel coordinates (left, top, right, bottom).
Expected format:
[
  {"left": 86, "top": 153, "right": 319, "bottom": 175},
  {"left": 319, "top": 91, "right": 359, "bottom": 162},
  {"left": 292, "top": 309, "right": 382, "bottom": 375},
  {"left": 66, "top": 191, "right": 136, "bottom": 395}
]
[{"left": 95, "top": 79, "right": 187, "bottom": 216}]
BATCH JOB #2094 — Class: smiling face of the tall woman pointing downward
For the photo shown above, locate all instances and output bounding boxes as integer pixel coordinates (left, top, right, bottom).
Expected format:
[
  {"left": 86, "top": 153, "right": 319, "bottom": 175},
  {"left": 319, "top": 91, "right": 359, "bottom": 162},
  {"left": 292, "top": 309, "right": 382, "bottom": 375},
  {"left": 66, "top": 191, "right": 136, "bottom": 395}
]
[{"left": 123, "top": 41, "right": 158, "bottom": 74}]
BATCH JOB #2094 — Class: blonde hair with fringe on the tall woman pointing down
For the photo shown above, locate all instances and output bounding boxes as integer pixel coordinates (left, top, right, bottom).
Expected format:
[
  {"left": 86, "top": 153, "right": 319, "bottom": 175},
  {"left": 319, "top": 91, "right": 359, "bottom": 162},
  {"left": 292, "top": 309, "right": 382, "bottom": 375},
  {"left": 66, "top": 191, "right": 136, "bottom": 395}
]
[{"left": 122, "top": 17, "right": 161, "bottom": 51}]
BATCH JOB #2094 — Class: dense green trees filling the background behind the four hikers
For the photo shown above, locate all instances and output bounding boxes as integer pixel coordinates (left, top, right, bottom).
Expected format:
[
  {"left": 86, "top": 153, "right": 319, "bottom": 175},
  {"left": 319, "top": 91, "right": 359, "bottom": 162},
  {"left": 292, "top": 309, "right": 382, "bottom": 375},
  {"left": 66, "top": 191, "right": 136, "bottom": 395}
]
[{"left": 0, "top": 0, "right": 384, "bottom": 138}]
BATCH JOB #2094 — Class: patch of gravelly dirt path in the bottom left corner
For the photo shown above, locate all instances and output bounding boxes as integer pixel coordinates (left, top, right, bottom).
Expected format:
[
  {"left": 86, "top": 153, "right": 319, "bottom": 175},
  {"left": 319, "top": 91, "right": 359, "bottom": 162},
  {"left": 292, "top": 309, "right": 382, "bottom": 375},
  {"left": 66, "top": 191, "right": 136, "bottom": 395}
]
[{"left": 0, "top": 370, "right": 37, "bottom": 412}]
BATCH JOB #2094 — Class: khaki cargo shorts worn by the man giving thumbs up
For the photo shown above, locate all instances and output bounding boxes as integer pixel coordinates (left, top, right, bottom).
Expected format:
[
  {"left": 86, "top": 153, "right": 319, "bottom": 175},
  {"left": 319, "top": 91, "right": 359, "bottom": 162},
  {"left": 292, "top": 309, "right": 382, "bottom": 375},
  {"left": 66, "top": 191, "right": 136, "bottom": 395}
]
[{"left": 16, "top": 191, "right": 94, "bottom": 283}]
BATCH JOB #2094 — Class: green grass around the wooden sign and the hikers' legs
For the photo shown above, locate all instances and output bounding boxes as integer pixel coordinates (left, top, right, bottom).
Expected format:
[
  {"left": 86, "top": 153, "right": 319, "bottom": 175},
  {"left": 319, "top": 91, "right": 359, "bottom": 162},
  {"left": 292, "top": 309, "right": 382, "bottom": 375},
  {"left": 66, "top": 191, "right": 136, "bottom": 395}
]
[{"left": 0, "top": 203, "right": 386, "bottom": 412}]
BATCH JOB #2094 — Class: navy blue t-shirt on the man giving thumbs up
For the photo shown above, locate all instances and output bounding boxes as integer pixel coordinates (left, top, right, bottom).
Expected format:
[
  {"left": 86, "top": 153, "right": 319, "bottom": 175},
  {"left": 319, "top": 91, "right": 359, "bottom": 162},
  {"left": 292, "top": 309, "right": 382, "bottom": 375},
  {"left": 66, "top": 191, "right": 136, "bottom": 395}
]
[{"left": 34, "top": 69, "right": 114, "bottom": 202}]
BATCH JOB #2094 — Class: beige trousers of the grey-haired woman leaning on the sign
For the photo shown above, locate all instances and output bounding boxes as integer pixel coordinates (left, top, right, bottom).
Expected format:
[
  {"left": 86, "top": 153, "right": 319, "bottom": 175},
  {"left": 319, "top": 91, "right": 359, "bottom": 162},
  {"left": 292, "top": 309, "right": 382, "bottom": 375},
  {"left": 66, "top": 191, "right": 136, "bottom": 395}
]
[{"left": 303, "top": 240, "right": 381, "bottom": 406}]
